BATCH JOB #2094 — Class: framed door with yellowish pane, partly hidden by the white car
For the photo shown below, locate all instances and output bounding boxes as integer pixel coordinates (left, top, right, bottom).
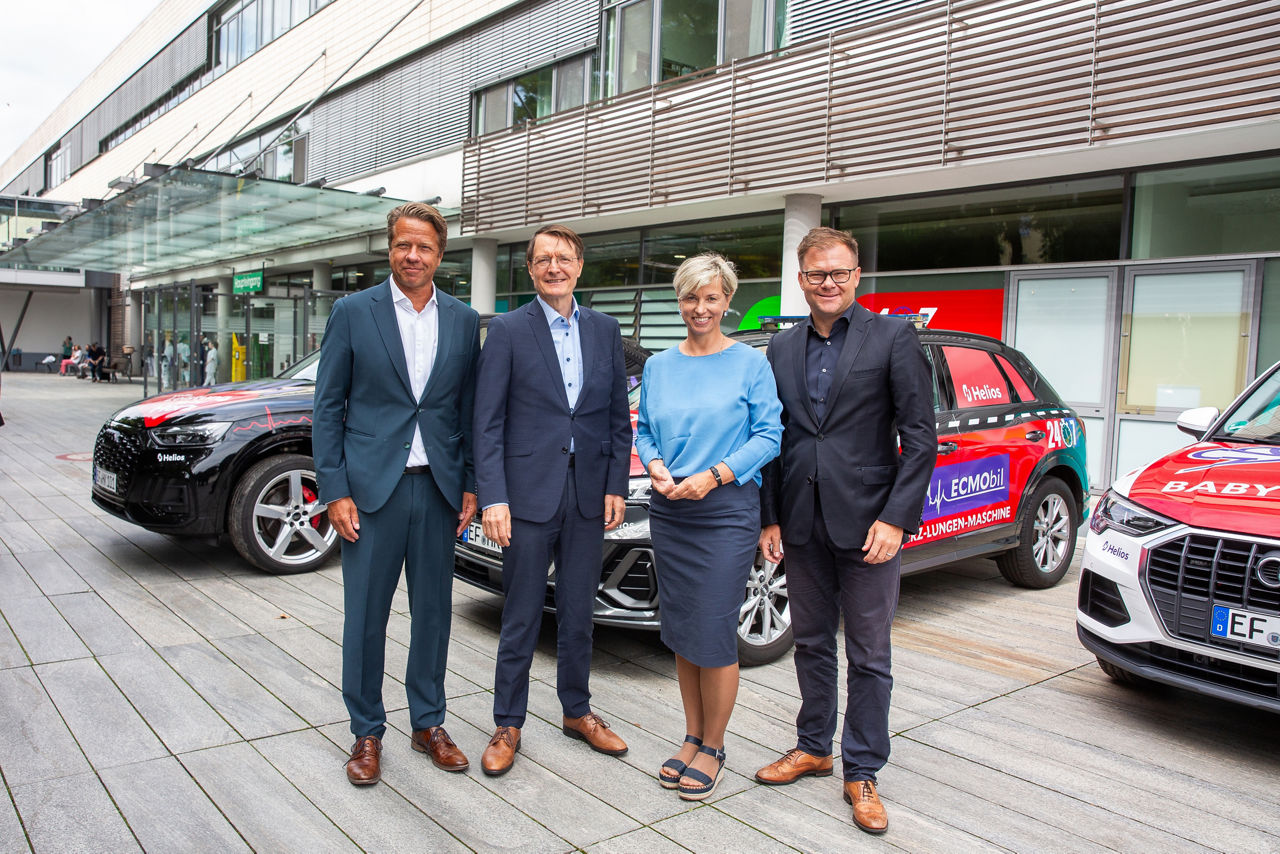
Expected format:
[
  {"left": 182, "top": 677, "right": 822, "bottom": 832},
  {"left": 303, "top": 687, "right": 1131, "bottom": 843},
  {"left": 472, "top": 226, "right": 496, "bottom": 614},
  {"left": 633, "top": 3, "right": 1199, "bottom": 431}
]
[{"left": 1114, "top": 261, "right": 1254, "bottom": 475}]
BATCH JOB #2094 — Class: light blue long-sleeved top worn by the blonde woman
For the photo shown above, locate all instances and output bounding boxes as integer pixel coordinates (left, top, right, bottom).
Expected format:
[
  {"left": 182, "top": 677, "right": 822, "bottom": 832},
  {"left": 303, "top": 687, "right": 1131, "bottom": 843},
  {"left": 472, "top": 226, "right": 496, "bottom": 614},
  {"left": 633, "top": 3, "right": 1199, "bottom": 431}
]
[{"left": 636, "top": 342, "right": 782, "bottom": 485}]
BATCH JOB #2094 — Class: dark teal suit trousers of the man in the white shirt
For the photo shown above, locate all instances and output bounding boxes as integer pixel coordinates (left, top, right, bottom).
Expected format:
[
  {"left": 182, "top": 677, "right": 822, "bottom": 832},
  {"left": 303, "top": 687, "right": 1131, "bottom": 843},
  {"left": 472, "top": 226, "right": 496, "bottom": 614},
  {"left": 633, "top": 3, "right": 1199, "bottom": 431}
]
[{"left": 342, "top": 474, "right": 458, "bottom": 737}]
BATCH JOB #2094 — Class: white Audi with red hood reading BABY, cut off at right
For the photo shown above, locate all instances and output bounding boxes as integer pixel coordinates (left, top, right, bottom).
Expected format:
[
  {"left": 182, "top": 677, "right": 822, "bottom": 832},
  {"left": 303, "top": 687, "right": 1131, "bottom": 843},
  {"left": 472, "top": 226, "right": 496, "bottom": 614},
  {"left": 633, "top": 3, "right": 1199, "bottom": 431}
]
[{"left": 1076, "top": 362, "right": 1280, "bottom": 712}]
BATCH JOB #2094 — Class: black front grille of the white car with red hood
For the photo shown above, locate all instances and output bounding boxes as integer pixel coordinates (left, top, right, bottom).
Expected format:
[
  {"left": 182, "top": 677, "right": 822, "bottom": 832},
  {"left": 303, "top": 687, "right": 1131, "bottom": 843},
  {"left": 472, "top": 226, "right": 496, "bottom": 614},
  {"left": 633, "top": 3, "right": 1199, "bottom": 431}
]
[{"left": 1144, "top": 534, "right": 1280, "bottom": 661}]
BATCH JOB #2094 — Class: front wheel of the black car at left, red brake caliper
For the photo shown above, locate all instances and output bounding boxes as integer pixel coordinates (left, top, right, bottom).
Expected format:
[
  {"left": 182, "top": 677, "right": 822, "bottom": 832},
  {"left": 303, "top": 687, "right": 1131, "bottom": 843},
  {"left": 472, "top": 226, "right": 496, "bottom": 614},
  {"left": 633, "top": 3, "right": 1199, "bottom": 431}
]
[{"left": 227, "top": 453, "right": 338, "bottom": 575}]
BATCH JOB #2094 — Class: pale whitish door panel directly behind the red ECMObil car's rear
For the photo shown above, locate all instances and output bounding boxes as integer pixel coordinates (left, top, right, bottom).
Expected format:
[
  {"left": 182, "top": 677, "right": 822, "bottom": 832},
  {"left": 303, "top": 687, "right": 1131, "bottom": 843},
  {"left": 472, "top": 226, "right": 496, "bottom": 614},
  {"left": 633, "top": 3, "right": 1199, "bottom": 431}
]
[{"left": 1010, "top": 268, "right": 1119, "bottom": 492}]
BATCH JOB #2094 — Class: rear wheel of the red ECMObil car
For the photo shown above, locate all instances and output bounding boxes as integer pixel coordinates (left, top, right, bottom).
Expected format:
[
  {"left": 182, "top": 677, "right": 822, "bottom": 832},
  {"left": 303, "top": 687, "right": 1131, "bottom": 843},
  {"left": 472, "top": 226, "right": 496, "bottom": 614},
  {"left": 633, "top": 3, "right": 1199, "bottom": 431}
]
[{"left": 996, "top": 478, "right": 1080, "bottom": 590}]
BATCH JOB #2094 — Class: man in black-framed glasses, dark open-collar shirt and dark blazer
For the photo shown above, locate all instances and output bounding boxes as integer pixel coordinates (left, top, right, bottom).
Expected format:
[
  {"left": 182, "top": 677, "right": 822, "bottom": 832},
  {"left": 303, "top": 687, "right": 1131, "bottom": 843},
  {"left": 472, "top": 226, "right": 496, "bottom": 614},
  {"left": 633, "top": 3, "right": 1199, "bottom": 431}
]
[{"left": 755, "top": 228, "right": 937, "bottom": 834}]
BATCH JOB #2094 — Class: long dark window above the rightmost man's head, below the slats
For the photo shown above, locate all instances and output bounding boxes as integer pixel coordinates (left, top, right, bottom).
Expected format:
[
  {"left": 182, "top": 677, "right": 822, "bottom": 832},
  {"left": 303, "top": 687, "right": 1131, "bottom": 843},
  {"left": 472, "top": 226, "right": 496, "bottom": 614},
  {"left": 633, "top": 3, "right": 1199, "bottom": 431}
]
[{"left": 836, "top": 177, "right": 1123, "bottom": 271}]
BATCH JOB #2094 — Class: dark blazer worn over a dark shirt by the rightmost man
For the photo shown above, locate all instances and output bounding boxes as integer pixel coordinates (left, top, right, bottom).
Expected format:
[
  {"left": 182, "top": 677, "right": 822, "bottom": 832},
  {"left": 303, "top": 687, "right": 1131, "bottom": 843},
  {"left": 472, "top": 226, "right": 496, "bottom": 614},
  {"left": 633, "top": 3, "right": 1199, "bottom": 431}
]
[{"left": 760, "top": 303, "right": 938, "bottom": 549}]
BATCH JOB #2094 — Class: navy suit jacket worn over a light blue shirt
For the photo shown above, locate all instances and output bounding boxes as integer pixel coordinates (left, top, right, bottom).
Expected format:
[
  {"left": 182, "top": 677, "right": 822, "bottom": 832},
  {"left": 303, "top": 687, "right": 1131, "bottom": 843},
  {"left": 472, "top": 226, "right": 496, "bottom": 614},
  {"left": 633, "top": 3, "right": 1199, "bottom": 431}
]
[{"left": 475, "top": 300, "right": 631, "bottom": 522}]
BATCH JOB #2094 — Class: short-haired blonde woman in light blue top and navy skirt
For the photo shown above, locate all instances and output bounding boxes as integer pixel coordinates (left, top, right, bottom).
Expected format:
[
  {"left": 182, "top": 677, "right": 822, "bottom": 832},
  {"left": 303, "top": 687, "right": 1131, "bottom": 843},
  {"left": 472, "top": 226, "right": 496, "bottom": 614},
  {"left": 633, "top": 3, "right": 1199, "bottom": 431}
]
[{"left": 636, "top": 252, "right": 782, "bottom": 800}]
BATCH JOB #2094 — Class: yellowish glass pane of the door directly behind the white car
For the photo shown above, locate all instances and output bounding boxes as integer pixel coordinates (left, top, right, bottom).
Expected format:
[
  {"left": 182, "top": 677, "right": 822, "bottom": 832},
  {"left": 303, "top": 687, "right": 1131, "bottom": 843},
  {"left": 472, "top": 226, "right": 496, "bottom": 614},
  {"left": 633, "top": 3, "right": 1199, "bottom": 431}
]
[{"left": 1120, "top": 270, "right": 1248, "bottom": 412}]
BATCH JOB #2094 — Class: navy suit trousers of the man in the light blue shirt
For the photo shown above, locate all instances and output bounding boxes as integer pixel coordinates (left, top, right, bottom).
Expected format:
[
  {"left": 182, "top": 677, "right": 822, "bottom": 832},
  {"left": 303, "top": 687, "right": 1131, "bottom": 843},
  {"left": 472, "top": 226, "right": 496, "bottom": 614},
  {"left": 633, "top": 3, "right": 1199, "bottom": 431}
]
[{"left": 493, "top": 466, "right": 604, "bottom": 727}]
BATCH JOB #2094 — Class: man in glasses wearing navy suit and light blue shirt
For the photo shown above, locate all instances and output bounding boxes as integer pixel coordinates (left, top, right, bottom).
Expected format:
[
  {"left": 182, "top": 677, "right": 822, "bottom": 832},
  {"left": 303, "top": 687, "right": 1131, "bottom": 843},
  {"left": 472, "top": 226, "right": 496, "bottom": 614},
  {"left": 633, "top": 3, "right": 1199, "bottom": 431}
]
[{"left": 475, "top": 225, "right": 631, "bottom": 776}]
